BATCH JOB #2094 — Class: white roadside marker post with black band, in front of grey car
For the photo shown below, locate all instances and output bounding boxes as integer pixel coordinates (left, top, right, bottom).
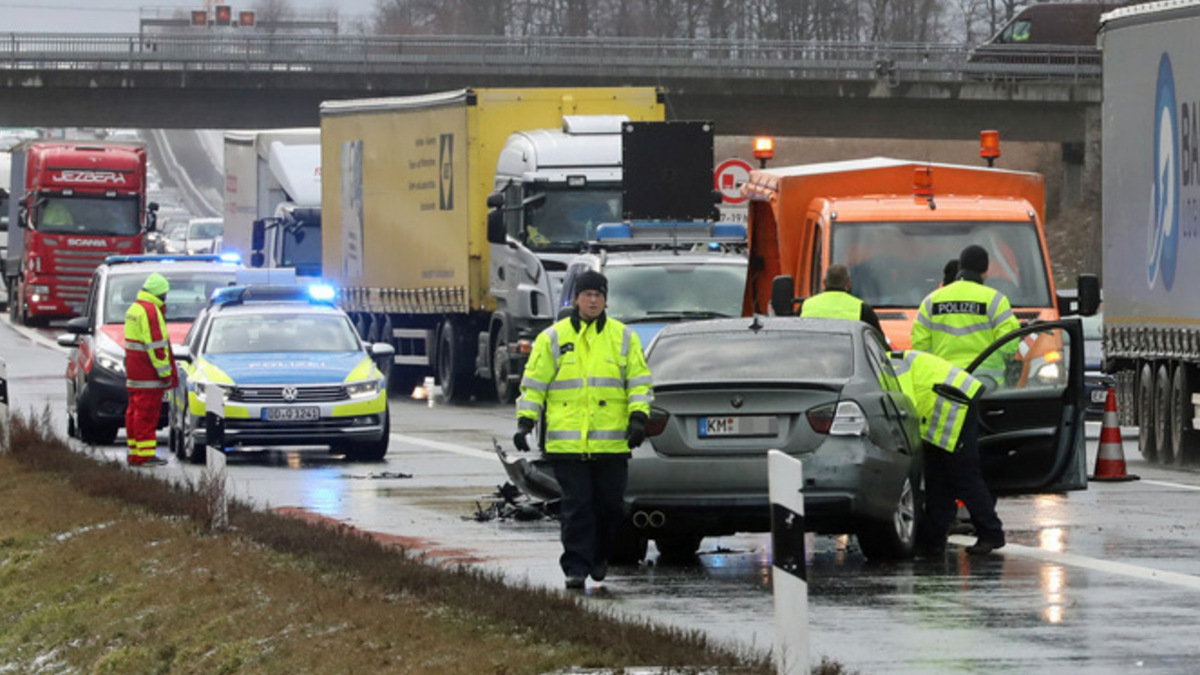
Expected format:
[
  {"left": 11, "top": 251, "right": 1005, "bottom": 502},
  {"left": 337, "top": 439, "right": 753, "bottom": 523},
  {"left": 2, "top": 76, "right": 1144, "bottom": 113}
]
[{"left": 767, "top": 450, "right": 809, "bottom": 675}]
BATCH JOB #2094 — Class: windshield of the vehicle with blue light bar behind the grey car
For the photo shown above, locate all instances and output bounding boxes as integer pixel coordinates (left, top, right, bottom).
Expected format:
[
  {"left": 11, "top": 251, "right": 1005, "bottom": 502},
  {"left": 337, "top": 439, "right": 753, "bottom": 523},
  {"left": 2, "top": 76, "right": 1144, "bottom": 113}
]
[{"left": 605, "top": 263, "right": 746, "bottom": 323}]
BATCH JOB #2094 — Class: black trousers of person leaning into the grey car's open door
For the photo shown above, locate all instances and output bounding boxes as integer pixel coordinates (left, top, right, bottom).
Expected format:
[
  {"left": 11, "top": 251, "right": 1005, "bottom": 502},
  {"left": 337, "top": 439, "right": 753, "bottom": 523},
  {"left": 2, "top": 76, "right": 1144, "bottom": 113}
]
[{"left": 917, "top": 411, "right": 1004, "bottom": 546}]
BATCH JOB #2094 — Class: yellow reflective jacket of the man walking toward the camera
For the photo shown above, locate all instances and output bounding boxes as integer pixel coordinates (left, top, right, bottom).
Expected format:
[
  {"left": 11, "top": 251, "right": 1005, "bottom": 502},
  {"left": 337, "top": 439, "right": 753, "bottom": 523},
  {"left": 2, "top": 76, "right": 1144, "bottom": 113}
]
[{"left": 517, "top": 315, "right": 653, "bottom": 454}]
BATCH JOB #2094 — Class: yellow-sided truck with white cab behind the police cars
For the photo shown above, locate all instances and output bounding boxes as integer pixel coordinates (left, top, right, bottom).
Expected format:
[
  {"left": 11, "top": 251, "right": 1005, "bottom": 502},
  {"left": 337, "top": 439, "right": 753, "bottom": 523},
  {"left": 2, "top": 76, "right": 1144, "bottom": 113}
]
[{"left": 320, "top": 88, "right": 664, "bottom": 401}]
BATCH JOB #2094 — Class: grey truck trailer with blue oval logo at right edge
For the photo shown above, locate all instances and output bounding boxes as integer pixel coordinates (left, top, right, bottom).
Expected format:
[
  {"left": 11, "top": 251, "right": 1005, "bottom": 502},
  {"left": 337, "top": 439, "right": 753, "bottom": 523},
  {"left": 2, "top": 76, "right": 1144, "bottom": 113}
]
[{"left": 1099, "top": 1, "right": 1200, "bottom": 464}]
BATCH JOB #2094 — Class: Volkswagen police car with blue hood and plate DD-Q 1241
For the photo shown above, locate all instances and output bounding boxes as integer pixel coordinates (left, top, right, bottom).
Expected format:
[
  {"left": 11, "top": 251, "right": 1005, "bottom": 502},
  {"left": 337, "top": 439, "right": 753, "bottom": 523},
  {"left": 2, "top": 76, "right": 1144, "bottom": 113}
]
[{"left": 169, "top": 285, "right": 394, "bottom": 464}]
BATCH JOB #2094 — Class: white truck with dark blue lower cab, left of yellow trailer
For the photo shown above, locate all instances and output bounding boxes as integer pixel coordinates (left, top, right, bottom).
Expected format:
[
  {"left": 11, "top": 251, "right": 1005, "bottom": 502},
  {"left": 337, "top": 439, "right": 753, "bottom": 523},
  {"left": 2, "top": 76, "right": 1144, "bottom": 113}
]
[{"left": 222, "top": 127, "right": 320, "bottom": 276}]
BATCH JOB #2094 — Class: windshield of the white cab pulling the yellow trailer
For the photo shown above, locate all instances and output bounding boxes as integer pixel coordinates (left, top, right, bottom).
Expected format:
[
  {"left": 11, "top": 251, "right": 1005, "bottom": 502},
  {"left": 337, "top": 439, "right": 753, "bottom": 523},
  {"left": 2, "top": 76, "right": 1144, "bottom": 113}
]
[{"left": 526, "top": 186, "right": 622, "bottom": 251}]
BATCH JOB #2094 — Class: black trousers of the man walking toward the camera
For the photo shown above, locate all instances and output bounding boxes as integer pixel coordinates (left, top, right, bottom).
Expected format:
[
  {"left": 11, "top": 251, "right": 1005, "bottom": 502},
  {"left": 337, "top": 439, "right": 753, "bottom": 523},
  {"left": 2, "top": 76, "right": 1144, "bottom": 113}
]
[{"left": 553, "top": 455, "right": 629, "bottom": 577}]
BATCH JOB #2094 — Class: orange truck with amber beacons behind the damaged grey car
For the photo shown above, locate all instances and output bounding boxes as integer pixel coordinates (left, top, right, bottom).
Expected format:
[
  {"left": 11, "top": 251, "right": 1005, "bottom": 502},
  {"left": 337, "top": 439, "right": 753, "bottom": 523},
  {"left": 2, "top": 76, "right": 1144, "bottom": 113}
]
[{"left": 743, "top": 145, "right": 1094, "bottom": 350}]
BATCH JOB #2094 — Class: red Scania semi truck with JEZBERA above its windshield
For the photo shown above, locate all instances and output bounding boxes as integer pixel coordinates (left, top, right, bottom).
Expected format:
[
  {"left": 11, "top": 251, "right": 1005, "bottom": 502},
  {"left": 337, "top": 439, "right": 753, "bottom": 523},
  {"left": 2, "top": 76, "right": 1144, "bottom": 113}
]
[{"left": 4, "top": 141, "right": 157, "bottom": 325}]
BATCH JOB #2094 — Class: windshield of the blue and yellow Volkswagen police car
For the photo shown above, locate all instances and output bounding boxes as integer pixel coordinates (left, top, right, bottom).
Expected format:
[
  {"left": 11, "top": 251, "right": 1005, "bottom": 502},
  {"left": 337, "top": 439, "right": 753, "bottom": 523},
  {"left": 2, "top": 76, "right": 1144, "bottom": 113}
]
[{"left": 203, "top": 312, "right": 361, "bottom": 354}]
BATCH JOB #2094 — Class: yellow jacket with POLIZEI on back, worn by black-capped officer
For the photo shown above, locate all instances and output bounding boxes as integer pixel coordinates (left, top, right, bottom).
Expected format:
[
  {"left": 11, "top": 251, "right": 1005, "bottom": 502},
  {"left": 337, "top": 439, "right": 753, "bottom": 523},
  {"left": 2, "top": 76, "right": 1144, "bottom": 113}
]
[{"left": 912, "top": 280, "right": 1021, "bottom": 371}]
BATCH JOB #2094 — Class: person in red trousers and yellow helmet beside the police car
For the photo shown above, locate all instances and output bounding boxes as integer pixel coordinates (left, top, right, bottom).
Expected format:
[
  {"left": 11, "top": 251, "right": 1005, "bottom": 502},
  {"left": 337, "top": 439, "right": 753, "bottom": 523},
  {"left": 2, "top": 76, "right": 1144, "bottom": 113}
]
[{"left": 125, "top": 273, "right": 178, "bottom": 466}]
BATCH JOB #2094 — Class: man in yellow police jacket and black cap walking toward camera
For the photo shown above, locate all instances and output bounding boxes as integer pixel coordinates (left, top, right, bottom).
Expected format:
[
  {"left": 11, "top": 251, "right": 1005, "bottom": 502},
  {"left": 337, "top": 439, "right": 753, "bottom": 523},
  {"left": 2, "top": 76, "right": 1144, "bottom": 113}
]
[{"left": 512, "top": 271, "right": 652, "bottom": 589}]
